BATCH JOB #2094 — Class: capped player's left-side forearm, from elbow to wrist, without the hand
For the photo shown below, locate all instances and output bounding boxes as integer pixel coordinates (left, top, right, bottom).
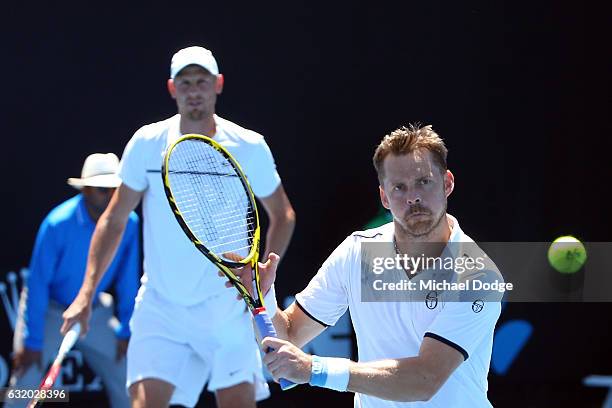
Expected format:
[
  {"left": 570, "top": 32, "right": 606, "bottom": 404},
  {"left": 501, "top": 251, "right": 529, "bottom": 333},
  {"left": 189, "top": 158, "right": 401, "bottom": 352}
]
[{"left": 80, "top": 212, "right": 125, "bottom": 302}]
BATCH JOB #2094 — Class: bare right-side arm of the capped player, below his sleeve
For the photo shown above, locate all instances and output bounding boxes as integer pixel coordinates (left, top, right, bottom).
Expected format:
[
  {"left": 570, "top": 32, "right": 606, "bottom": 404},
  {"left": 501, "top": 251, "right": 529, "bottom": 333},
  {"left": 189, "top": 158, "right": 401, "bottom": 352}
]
[{"left": 259, "top": 184, "right": 295, "bottom": 259}]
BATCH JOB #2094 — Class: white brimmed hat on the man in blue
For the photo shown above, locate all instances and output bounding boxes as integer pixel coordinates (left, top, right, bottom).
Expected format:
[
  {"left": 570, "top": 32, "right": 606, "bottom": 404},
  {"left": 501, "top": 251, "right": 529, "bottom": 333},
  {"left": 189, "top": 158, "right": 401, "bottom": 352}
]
[{"left": 68, "top": 153, "right": 121, "bottom": 190}]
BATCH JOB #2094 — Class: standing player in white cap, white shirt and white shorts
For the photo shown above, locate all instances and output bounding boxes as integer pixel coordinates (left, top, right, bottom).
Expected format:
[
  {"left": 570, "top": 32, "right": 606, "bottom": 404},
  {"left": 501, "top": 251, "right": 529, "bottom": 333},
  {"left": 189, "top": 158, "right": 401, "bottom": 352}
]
[{"left": 62, "top": 47, "right": 295, "bottom": 407}]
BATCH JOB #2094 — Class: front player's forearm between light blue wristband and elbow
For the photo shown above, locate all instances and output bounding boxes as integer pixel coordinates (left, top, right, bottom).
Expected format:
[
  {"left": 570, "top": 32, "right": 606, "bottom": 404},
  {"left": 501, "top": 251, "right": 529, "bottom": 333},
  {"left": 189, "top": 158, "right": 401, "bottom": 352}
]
[{"left": 348, "top": 357, "right": 445, "bottom": 401}]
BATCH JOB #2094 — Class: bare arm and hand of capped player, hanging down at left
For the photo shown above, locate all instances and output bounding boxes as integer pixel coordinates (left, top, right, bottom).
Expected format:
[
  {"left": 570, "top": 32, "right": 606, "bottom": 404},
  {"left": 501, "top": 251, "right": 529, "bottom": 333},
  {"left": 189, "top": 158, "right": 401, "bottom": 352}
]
[{"left": 61, "top": 184, "right": 142, "bottom": 335}]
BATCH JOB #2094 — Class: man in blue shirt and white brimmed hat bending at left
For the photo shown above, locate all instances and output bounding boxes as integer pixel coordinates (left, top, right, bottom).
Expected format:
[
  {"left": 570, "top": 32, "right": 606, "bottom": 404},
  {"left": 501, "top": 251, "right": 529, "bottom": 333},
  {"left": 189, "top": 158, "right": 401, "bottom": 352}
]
[{"left": 7, "top": 153, "right": 140, "bottom": 407}]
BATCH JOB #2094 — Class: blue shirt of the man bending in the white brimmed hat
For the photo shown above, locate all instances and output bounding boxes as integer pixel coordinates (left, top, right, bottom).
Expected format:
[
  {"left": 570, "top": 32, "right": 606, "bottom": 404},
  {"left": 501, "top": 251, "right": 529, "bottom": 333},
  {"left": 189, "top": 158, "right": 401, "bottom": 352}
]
[{"left": 24, "top": 194, "right": 140, "bottom": 350}]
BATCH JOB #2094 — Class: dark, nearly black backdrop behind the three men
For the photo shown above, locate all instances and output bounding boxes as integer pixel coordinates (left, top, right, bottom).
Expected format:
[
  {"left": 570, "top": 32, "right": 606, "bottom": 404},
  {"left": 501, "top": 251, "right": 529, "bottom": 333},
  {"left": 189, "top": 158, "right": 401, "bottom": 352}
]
[{"left": 0, "top": 0, "right": 612, "bottom": 406}]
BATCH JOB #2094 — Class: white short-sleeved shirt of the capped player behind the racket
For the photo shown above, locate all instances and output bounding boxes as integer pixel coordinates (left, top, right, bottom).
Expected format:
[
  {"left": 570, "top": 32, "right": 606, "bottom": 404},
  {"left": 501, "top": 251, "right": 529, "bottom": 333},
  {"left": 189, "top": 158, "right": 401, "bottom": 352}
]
[{"left": 119, "top": 115, "right": 280, "bottom": 306}]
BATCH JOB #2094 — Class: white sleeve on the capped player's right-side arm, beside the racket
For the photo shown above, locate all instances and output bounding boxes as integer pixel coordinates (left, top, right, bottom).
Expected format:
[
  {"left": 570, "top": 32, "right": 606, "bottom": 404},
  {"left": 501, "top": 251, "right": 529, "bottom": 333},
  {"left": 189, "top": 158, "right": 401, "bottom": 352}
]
[{"left": 247, "top": 137, "right": 281, "bottom": 197}]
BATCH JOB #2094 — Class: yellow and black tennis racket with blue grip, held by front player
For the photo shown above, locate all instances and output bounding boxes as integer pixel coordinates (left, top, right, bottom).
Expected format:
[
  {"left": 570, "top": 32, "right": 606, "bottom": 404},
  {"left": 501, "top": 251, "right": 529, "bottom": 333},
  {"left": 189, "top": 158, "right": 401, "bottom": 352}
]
[{"left": 161, "top": 134, "right": 295, "bottom": 390}]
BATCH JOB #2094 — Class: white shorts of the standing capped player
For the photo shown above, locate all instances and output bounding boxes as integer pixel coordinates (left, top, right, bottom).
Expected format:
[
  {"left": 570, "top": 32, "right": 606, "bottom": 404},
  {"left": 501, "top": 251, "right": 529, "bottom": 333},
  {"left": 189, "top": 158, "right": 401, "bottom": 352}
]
[{"left": 127, "top": 286, "right": 269, "bottom": 407}]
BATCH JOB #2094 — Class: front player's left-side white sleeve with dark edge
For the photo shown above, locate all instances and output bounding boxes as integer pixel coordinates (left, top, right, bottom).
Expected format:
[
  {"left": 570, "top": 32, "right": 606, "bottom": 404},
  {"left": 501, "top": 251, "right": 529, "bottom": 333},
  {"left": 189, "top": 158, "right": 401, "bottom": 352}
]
[{"left": 295, "top": 237, "right": 359, "bottom": 326}]
